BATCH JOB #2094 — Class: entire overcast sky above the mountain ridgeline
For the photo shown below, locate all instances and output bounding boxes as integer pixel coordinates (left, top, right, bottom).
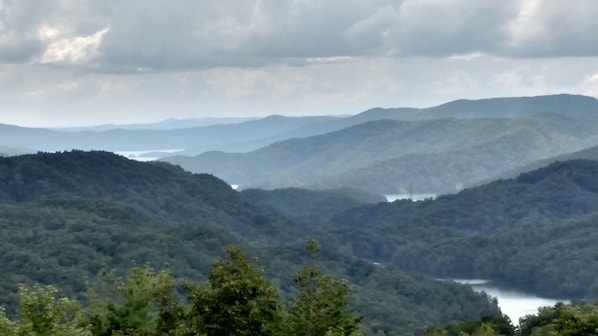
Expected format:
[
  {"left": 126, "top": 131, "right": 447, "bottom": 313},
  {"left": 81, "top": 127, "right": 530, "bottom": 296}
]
[{"left": 0, "top": 0, "right": 598, "bottom": 127}]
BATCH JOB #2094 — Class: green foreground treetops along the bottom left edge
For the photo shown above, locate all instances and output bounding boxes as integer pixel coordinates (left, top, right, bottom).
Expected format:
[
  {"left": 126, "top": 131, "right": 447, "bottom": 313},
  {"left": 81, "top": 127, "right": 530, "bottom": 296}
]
[{"left": 0, "top": 247, "right": 360, "bottom": 336}]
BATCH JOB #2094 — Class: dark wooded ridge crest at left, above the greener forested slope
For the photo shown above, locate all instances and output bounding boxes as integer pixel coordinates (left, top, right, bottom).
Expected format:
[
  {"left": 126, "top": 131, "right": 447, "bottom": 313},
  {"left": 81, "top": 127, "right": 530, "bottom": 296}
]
[{"left": 0, "top": 151, "right": 294, "bottom": 242}]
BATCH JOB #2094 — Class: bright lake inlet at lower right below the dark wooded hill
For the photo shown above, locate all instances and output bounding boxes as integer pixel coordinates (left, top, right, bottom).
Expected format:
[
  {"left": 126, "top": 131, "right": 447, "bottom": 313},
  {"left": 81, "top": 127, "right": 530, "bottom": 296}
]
[{"left": 454, "top": 279, "right": 570, "bottom": 325}]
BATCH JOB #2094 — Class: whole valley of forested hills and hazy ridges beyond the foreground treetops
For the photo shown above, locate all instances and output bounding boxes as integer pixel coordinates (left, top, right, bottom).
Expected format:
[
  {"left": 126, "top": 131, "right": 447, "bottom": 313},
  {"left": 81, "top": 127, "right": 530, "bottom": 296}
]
[{"left": 0, "top": 95, "right": 598, "bottom": 335}]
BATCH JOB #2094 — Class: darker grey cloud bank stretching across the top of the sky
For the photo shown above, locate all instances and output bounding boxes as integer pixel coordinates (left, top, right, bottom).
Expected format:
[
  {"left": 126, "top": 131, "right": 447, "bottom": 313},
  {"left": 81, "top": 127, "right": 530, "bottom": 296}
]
[{"left": 0, "top": 0, "right": 598, "bottom": 72}]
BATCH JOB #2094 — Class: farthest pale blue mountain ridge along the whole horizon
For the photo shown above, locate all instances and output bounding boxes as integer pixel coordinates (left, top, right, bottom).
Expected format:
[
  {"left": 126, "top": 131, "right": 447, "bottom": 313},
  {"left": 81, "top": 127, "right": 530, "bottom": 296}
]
[{"left": 0, "top": 94, "right": 598, "bottom": 155}]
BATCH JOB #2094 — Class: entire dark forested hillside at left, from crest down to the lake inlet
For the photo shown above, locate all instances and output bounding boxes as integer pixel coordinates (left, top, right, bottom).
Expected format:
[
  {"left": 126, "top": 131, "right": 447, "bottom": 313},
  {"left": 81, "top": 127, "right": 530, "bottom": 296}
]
[{"left": 0, "top": 151, "right": 498, "bottom": 335}]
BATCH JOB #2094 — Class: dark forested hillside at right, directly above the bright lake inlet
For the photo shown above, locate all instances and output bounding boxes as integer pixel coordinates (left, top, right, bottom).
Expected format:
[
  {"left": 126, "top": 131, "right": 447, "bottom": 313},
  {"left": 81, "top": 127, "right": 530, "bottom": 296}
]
[{"left": 328, "top": 160, "right": 598, "bottom": 299}]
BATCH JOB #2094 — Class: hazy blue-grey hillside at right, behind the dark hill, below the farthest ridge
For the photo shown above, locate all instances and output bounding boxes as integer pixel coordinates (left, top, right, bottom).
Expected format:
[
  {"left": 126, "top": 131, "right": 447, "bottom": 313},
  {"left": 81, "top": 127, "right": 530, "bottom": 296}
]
[{"left": 165, "top": 114, "right": 598, "bottom": 194}]
